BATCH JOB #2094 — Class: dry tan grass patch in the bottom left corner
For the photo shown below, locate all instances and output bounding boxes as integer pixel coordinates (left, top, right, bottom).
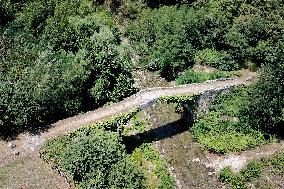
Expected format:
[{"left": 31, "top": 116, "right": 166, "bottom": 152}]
[{"left": 0, "top": 157, "right": 69, "bottom": 189}]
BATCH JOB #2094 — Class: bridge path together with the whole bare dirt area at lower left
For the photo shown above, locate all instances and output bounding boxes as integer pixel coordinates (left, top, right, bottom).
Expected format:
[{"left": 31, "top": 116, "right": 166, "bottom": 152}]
[{"left": 0, "top": 78, "right": 250, "bottom": 188}]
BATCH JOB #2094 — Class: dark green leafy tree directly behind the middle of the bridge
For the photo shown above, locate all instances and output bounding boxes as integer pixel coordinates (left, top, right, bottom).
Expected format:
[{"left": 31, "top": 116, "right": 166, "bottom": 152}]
[{"left": 127, "top": 7, "right": 194, "bottom": 78}]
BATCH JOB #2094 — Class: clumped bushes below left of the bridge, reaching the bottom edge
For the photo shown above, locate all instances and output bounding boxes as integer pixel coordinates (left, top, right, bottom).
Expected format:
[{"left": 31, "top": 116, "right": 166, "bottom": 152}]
[{"left": 60, "top": 130, "right": 143, "bottom": 188}]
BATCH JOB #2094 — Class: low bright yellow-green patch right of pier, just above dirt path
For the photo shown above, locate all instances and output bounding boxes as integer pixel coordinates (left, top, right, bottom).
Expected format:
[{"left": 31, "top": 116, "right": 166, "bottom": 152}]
[{"left": 191, "top": 112, "right": 266, "bottom": 153}]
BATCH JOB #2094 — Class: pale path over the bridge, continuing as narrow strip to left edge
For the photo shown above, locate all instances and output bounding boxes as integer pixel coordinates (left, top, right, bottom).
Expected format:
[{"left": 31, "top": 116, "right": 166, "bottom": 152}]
[{"left": 0, "top": 78, "right": 250, "bottom": 165}]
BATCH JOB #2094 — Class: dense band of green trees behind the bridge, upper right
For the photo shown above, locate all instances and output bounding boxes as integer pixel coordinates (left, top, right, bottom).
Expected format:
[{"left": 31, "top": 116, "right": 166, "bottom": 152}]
[{"left": 127, "top": 0, "right": 283, "bottom": 78}]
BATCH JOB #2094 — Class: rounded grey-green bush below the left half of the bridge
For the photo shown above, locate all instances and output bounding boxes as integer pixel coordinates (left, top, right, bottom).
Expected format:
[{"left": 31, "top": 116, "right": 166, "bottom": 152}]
[{"left": 60, "top": 130, "right": 124, "bottom": 183}]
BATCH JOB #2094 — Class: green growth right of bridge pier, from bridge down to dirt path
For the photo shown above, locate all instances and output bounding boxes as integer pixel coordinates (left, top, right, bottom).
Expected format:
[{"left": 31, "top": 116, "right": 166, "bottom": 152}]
[{"left": 191, "top": 87, "right": 274, "bottom": 153}]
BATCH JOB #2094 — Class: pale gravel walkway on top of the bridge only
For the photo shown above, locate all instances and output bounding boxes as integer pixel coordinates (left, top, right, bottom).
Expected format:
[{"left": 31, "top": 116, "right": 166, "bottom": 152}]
[{"left": 44, "top": 78, "right": 249, "bottom": 139}]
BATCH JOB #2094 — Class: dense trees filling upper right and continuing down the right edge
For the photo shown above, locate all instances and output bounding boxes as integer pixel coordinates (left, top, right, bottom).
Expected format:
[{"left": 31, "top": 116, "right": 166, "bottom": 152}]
[{"left": 126, "top": 0, "right": 284, "bottom": 140}]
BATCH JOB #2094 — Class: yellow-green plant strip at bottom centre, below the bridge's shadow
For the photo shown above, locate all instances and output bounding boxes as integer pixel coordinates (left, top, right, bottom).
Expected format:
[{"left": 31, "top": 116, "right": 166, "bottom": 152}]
[{"left": 130, "top": 143, "right": 175, "bottom": 189}]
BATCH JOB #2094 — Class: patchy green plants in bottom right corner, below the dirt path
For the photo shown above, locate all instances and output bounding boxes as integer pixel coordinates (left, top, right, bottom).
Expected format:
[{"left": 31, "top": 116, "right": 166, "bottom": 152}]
[{"left": 218, "top": 152, "right": 284, "bottom": 189}]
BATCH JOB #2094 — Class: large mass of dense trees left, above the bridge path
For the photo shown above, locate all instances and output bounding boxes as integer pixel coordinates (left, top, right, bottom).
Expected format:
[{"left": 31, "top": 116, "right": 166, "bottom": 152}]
[{"left": 0, "top": 0, "right": 133, "bottom": 133}]
